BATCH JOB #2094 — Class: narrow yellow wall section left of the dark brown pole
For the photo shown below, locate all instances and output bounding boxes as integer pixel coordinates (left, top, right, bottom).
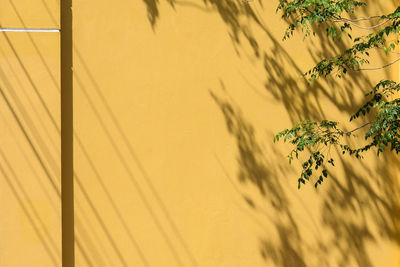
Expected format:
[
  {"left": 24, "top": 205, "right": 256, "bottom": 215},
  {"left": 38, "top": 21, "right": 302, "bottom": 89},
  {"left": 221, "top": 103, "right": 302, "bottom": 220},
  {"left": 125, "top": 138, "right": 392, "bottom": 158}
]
[{"left": 0, "top": 0, "right": 61, "bottom": 267}]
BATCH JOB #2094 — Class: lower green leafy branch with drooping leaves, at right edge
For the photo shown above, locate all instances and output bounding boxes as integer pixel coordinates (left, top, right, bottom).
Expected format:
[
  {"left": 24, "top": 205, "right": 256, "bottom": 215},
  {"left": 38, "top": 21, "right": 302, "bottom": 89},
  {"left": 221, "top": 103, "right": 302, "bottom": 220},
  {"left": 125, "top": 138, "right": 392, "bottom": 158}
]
[{"left": 274, "top": 80, "right": 400, "bottom": 188}]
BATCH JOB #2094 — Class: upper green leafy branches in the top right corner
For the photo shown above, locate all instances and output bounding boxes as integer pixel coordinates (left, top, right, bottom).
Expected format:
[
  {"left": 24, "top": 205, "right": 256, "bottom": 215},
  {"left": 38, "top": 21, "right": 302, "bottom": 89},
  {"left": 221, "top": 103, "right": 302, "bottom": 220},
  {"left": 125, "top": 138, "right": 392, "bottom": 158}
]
[{"left": 277, "top": 0, "right": 400, "bottom": 82}]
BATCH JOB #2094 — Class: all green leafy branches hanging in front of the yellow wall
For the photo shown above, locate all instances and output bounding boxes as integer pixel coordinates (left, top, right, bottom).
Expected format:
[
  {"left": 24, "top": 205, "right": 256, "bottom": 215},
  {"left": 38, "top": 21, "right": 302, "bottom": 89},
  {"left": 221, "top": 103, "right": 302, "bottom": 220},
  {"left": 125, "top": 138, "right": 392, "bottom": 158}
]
[{"left": 274, "top": 0, "right": 400, "bottom": 188}]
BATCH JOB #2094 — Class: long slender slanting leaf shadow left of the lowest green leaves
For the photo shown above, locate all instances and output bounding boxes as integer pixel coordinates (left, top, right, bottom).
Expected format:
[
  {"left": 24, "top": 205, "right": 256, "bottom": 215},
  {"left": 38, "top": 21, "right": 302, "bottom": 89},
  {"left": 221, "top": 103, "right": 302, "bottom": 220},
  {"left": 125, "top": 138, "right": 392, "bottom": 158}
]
[{"left": 211, "top": 92, "right": 306, "bottom": 267}]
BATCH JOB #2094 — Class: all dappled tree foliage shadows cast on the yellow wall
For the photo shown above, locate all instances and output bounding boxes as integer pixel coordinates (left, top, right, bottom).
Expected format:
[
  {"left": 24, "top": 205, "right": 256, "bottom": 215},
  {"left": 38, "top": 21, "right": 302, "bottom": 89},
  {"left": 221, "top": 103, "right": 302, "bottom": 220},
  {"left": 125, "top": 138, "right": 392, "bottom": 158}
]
[{"left": 143, "top": 0, "right": 400, "bottom": 267}]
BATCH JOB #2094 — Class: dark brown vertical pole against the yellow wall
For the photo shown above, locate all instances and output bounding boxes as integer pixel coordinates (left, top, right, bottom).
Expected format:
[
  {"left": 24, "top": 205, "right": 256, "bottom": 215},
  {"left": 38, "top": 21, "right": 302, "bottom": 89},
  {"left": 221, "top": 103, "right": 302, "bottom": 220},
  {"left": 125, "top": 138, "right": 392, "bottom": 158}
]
[{"left": 60, "top": 0, "right": 75, "bottom": 267}]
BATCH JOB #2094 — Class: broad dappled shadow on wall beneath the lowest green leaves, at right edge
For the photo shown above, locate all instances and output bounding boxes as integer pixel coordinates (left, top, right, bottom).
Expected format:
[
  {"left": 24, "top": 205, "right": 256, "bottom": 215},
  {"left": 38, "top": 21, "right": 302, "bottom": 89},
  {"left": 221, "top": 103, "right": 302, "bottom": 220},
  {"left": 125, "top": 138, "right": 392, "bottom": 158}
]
[{"left": 321, "top": 154, "right": 400, "bottom": 266}]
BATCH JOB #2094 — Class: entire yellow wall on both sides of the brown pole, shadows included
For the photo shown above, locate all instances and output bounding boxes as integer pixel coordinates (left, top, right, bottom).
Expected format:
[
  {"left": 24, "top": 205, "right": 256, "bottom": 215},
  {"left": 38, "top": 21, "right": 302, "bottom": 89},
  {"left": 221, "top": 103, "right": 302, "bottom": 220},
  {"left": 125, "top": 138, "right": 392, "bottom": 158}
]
[{"left": 0, "top": 0, "right": 400, "bottom": 267}]
